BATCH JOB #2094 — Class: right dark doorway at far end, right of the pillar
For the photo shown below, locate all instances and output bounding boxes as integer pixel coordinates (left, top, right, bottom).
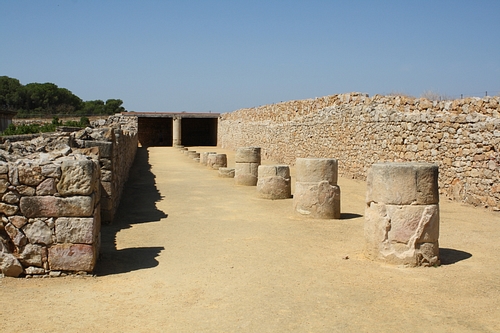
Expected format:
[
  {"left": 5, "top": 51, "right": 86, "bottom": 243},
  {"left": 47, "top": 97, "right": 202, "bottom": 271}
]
[{"left": 181, "top": 118, "right": 218, "bottom": 146}]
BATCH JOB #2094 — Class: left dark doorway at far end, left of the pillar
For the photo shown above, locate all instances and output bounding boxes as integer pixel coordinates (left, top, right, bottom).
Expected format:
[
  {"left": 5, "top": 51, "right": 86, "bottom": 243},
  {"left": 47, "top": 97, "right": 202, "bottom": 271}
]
[{"left": 138, "top": 117, "right": 172, "bottom": 147}]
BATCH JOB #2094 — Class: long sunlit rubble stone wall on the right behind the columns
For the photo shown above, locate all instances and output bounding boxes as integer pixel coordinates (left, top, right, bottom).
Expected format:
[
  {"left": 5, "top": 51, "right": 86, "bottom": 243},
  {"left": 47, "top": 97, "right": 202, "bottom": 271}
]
[{"left": 218, "top": 93, "right": 500, "bottom": 209}]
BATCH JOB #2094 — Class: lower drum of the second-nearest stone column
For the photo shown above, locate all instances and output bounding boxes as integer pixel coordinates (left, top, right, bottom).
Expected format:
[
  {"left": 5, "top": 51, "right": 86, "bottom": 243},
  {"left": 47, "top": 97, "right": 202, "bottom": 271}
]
[{"left": 293, "top": 181, "right": 340, "bottom": 219}]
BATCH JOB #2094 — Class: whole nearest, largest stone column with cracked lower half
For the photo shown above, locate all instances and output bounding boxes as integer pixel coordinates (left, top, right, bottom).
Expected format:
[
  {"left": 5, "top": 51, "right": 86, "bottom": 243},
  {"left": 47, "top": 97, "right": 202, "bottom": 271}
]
[{"left": 364, "top": 163, "right": 439, "bottom": 266}]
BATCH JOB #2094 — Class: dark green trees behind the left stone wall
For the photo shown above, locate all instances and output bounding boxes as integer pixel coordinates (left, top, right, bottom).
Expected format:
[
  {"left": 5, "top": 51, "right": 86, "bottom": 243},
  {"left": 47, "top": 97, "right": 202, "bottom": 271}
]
[{"left": 0, "top": 76, "right": 127, "bottom": 118}]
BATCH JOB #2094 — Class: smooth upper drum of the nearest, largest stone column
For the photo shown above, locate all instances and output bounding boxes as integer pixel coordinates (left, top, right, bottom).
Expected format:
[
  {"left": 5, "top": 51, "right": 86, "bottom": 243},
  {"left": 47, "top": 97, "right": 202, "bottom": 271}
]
[{"left": 366, "top": 163, "right": 439, "bottom": 205}]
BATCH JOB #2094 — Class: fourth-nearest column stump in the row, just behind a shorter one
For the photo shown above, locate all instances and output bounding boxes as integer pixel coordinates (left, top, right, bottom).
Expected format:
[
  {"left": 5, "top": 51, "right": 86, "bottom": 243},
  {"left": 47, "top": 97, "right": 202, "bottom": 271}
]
[{"left": 234, "top": 147, "right": 260, "bottom": 186}]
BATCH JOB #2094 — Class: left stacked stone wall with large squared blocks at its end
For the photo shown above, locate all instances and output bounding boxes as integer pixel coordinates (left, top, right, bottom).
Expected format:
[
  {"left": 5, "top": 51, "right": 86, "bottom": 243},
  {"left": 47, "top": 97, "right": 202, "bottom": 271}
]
[{"left": 0, "top": 116, "right": 137, "bottom": 276}]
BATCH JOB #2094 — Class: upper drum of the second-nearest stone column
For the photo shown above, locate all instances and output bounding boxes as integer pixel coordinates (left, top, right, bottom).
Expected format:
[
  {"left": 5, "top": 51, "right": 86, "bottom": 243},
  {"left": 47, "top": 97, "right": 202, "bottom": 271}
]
[{"left": 295, "top": 158, "right": 338, "bottom": 185}]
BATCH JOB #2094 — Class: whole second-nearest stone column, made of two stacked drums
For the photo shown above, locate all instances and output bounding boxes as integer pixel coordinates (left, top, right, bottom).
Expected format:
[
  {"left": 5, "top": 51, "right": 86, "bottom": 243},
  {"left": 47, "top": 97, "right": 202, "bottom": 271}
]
[{"left": 293, "top": 158, "right": 340, "bottom": 219}]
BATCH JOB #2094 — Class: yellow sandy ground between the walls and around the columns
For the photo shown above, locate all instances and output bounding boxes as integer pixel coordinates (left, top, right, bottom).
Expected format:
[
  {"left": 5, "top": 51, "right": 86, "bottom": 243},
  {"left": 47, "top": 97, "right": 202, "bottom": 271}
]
[{"left": 0, "top": 147, "right": 500, "bottom": 332}]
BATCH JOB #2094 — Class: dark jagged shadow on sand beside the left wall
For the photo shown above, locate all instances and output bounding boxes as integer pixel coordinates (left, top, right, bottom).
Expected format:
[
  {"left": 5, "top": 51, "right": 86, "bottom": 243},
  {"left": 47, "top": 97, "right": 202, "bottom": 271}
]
[{"left": 95, "top": 147, "right": 167, "bottom": 276}]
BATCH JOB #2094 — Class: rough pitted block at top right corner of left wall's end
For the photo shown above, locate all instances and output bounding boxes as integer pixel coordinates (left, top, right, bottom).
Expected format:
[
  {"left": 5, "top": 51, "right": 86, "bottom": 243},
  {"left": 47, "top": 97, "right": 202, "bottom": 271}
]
[{"left": 57, "top": 160, "right": 99, "bottom": 196}]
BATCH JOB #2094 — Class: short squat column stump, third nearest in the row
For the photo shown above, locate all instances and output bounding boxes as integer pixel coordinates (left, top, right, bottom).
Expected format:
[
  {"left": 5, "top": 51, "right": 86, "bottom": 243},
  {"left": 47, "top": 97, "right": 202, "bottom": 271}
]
[{"left": 257, "top": 165, "right": 292, "bottom": 200}]
